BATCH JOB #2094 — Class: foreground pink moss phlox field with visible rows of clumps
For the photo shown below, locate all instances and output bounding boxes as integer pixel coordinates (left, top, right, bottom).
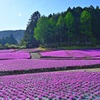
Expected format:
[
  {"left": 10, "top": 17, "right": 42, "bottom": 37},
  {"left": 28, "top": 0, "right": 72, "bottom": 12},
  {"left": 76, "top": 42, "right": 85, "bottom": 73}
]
[{"left": 0, "top": 71, "right": 100, "bottom": 100}]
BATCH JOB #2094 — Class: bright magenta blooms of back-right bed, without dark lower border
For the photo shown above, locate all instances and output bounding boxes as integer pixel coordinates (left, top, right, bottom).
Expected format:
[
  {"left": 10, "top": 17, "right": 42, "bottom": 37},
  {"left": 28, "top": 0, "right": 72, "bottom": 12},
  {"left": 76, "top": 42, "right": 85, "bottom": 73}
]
[{"left": 41, "top": 50, "right": 100, "bottom": 58}]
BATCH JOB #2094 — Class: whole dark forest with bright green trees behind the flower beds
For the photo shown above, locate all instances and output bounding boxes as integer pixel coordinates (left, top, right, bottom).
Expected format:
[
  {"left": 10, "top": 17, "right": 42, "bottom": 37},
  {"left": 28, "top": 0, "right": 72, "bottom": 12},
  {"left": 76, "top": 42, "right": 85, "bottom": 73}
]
[{"left": 21, "top": 5, "right": 100, "bottom": 48}]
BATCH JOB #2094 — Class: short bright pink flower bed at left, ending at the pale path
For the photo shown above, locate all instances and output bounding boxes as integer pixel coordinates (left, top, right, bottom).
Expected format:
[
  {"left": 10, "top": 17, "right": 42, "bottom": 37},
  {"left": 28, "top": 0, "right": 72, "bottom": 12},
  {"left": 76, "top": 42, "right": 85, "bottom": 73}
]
[{"left": 0, "top": 51, "right": 30, "bottom": 60}]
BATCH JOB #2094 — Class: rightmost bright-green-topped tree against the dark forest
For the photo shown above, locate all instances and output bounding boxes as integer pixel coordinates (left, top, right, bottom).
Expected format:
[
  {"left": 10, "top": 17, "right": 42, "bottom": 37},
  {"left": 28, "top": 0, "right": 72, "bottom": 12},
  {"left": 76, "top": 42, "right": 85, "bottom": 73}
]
[{"left": 80, "top": 10, "right": 94, "bottom": 44}]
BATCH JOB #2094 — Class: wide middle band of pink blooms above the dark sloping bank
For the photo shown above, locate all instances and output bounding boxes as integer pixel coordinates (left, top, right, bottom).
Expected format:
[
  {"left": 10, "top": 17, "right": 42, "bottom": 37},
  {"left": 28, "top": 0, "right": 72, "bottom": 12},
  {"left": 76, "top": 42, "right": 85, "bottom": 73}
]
[{"left": 0, "top": 59, "right": 100, "bottom": 71}]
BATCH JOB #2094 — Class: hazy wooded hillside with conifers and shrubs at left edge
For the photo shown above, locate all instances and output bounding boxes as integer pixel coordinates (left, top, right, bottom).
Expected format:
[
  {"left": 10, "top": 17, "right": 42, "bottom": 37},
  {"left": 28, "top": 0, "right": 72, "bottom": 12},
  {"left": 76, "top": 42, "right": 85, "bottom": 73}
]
[{"left": 0, "top": 30, "right": 24, "bottom": 49}]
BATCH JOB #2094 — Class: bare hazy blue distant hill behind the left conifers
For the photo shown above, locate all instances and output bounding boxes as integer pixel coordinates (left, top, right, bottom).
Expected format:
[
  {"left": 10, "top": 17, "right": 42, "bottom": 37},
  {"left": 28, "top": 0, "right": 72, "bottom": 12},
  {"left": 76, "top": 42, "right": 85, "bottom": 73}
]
[{"left": 0, "top": 30, "right": 25, "bottom": 43}]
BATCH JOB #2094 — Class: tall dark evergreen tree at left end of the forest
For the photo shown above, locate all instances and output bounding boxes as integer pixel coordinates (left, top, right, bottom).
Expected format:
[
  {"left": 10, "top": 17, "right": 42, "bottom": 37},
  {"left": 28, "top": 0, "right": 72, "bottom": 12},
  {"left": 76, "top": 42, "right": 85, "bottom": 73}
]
[{"left": 23, "top": 11, "right": 40, "bottom": 48}]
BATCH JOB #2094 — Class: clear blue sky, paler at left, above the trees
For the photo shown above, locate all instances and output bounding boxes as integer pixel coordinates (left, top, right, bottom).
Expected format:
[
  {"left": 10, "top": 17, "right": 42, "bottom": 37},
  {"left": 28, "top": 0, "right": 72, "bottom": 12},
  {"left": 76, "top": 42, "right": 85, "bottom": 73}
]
[{"left": 0, "top": 0, "right": 100, "bottom": 31}]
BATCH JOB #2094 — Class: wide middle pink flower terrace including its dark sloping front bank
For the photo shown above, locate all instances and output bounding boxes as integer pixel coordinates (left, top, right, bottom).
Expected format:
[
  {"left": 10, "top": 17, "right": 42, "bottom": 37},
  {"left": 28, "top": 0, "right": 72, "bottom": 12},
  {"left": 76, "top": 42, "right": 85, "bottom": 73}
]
[{"left": 0, "top": 59, "right": 100, "bottom": 75}]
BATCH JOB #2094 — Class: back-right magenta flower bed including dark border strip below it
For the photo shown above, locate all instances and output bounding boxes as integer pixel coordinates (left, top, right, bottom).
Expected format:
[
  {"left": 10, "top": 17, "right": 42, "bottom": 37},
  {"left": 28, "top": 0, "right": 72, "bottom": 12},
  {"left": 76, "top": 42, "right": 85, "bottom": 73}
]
[{"left": 40, "top": 50, "right": 100, "bottom": 59}]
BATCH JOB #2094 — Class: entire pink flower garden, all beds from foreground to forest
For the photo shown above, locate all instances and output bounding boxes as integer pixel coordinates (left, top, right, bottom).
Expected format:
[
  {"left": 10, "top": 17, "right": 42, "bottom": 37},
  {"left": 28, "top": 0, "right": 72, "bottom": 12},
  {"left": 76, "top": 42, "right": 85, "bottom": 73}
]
[{"left": 0, "top": 49, "right": 100, "bottom": 100}]
